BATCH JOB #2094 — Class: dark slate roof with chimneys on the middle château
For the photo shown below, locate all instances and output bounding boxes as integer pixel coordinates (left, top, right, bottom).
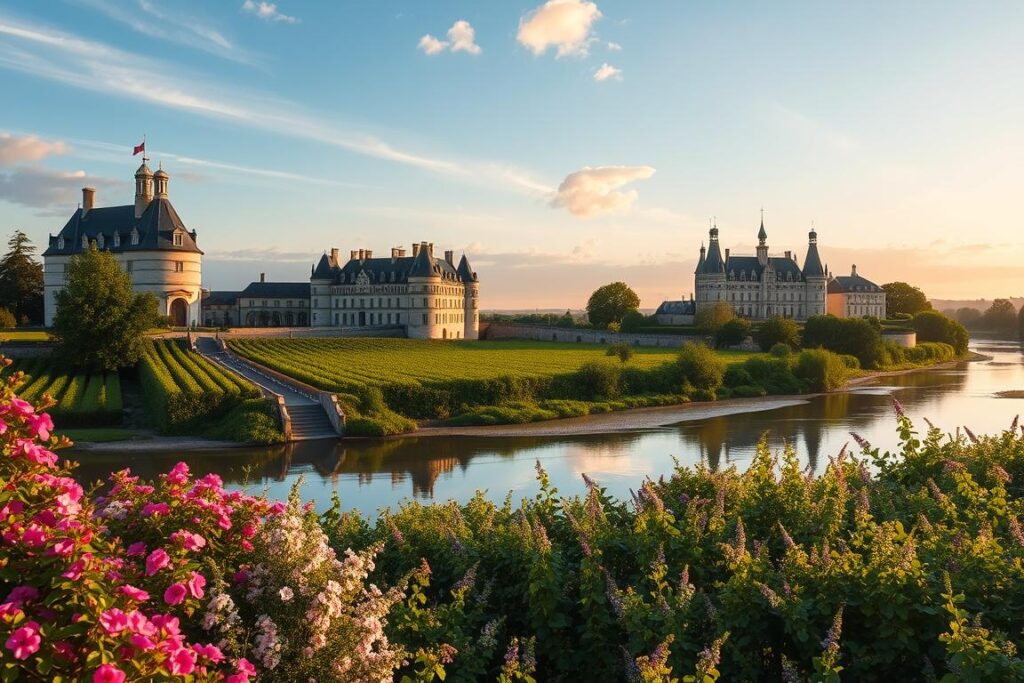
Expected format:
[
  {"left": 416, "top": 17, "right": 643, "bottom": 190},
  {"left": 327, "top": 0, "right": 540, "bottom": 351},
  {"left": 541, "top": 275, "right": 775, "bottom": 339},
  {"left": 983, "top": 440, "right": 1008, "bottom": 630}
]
[{"left": 311, "top": 248, "right": 477, "bottom": 285}]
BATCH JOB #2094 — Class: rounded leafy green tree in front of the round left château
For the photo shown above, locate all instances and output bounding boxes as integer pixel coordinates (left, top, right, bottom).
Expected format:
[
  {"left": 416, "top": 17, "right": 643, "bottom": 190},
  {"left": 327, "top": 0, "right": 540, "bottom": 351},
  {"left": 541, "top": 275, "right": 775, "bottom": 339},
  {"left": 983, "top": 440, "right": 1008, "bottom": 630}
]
[{"left": 51, "top": 246, "right": 157, "bottom": 370}]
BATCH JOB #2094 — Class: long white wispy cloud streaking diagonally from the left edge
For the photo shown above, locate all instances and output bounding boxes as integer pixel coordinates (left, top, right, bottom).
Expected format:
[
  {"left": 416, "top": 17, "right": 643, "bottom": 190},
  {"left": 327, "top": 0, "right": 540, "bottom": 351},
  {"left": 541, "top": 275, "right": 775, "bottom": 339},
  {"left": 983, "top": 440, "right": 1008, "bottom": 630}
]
[{"left": 0, "top": 16, "right": 537, "bottom": 193}]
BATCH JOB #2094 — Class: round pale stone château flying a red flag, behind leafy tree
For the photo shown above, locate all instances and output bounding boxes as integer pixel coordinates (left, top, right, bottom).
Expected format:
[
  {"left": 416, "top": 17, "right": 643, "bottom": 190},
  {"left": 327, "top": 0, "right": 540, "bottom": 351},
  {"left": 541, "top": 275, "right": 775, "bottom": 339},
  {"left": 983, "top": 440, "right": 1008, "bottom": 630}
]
[{"left": 43, "top": 160, "right": 203, "bottom": 327}]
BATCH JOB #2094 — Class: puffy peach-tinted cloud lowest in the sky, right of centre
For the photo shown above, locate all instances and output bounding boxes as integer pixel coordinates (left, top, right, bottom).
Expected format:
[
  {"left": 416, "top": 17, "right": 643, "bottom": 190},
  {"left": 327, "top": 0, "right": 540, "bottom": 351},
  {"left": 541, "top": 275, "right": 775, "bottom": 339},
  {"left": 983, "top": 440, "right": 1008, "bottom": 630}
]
[{"left": 551, "top": 166, "right": 654, "bottom": 218}]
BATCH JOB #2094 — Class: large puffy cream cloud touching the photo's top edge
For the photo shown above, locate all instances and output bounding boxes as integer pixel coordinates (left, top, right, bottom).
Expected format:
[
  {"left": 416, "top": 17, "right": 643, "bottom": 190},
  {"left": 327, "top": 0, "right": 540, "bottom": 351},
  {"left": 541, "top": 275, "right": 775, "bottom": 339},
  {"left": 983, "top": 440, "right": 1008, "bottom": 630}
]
[{"left": 516, "top": 0, "right": 601, "bottom": 57}]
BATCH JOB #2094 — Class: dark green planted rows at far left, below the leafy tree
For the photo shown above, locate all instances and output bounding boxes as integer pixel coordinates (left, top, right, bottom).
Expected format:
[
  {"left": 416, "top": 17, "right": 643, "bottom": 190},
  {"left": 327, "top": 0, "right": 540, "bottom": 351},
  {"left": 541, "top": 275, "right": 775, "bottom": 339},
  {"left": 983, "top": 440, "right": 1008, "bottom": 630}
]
[{"left": 14, "top": 358, "right": 123, "bottom": 427}]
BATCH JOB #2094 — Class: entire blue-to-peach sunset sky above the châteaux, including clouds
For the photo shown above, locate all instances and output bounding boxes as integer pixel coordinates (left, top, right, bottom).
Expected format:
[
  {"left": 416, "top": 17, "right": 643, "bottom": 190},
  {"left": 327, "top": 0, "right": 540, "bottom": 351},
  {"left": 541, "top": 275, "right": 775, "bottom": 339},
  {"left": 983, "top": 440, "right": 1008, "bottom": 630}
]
[{"left": 0, "top": 0, "right": 1024, "bottom": 309}]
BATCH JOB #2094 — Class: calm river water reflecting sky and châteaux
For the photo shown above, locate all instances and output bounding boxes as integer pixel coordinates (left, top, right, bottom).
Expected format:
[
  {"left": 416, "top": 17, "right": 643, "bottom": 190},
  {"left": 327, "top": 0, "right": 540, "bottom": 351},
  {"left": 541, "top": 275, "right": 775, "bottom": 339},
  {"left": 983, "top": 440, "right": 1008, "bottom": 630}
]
[{"left": 79, "top": 342, "right": 1024, "bottom": 513}]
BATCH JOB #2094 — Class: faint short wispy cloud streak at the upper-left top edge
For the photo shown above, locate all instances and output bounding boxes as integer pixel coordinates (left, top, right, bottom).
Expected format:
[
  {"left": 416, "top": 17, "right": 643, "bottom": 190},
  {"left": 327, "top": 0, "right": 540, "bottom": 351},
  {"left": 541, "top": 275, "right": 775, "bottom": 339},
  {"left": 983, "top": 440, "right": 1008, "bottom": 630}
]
[{"left": 74, "top": 0, "right": 257, "bottom": 63}]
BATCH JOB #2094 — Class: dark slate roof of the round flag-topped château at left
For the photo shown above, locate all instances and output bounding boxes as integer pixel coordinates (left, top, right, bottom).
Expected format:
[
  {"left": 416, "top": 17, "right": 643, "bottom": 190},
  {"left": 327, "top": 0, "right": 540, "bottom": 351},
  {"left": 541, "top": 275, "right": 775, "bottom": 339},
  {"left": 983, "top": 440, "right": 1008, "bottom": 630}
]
[{"left": 43, "top": 198, "right": 203, "bottom": 256}]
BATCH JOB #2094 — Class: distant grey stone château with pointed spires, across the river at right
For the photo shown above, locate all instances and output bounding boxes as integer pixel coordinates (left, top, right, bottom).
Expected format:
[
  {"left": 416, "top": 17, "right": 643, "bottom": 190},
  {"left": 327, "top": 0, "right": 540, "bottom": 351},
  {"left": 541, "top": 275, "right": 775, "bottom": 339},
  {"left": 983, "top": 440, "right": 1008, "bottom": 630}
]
[{"left": 694, "top": 220, "right": 827, "bottom": 321}]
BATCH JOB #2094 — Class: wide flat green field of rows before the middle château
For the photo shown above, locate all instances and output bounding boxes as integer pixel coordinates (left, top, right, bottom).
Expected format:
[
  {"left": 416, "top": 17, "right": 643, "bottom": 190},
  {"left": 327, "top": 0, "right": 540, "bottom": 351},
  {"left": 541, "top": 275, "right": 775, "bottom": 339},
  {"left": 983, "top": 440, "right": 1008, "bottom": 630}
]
[{"left": 228, "top": 338, "right": 751, "bottom": 390}]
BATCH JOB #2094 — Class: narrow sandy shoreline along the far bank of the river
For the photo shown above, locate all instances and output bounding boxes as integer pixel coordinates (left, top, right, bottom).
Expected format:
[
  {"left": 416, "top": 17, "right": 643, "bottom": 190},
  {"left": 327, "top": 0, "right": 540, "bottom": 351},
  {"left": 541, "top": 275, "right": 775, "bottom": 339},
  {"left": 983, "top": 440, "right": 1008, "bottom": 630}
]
[{"left": 74, "top": 353, "right": 974, "bottom": 453}]
